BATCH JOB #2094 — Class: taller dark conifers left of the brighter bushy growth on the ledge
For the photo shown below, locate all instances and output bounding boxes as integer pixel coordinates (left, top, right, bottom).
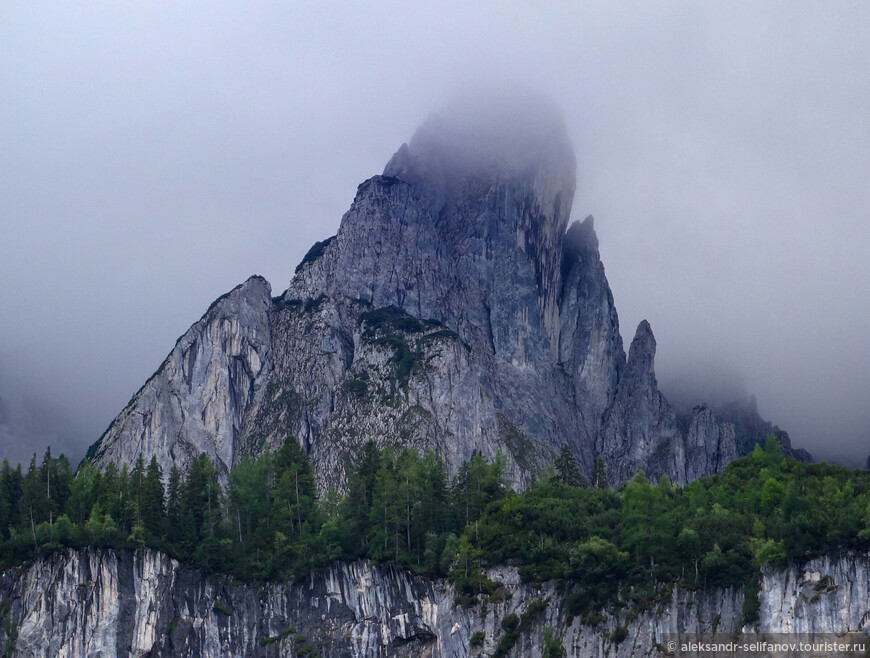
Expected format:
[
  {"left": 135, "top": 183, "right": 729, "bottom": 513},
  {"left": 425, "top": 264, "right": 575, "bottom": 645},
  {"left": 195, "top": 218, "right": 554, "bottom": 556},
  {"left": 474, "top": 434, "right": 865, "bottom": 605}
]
[{"left": 0, "top": 437, "right": 507, "bottom": 582}]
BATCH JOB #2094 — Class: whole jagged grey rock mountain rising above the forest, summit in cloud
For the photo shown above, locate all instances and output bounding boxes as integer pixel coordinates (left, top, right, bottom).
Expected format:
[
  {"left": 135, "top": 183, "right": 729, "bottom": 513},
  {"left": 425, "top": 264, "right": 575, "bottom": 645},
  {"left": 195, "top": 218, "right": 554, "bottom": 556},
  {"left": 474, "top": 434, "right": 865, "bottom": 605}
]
[{"left": 89, "top": 98, "right": 808, "bottom": 489}]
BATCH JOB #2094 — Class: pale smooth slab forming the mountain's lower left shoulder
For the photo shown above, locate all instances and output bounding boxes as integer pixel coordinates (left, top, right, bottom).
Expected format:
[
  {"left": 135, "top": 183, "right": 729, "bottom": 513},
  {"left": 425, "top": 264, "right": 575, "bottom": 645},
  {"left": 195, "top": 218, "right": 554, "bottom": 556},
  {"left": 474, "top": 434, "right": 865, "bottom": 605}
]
[{"left": 90, "top": 277, "right": 272, "bottom": 472}]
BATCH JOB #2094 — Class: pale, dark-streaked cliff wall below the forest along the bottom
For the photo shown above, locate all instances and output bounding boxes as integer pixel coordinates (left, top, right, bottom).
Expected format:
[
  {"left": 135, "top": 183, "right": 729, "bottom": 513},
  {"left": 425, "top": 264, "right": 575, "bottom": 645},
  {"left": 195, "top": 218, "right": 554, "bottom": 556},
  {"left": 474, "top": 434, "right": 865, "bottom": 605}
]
[{"left": 0, "top": 549, "right": 870, "bottom": 658}]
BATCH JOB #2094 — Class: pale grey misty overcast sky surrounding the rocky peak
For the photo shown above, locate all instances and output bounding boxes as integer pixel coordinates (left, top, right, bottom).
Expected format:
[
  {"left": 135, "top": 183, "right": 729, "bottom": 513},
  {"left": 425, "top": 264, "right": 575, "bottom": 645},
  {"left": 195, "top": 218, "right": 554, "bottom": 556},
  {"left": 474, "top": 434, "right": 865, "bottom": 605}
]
[{"left": 0, "top": 1, "right": 870, "bottom": 464}]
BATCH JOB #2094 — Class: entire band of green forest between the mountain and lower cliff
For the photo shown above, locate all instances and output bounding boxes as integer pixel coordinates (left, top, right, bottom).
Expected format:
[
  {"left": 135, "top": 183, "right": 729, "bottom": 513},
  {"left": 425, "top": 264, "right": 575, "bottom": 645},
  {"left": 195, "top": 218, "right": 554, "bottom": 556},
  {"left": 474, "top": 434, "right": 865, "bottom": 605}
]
[{"left": 0, "top": 437, "right": 870, "bottom": 621}]
